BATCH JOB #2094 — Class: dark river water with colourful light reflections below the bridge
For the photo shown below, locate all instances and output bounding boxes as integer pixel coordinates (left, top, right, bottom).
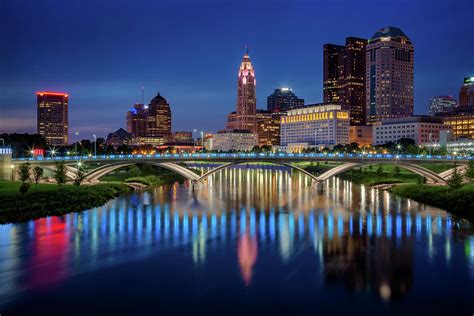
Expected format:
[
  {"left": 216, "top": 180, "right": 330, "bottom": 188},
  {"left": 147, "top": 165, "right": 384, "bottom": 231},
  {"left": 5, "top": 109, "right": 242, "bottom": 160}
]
[{"left": 0, "top": 168, "right": 474, "bottom": 316}]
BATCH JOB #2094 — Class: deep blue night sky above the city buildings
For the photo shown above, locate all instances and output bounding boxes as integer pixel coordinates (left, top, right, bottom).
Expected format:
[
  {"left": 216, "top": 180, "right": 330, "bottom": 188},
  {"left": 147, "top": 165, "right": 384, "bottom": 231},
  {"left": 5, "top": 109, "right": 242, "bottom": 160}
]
[{"left": 0, "top": 0, "right": 474, "bottom": 138}]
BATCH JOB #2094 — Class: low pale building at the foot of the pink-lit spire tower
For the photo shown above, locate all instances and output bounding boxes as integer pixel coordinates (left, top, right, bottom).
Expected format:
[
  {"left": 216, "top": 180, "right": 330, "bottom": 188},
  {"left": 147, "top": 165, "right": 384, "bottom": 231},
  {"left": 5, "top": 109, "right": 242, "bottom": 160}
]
[{"left": 212, "top": 130, "right": 257, "bottom": 151}]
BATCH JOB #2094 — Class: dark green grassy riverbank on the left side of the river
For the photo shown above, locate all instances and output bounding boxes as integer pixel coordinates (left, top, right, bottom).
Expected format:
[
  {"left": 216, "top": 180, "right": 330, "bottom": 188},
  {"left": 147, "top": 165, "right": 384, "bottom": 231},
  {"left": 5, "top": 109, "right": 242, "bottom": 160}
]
[{"left": 0, "top": 181, "right": 130, "bottom": 224}]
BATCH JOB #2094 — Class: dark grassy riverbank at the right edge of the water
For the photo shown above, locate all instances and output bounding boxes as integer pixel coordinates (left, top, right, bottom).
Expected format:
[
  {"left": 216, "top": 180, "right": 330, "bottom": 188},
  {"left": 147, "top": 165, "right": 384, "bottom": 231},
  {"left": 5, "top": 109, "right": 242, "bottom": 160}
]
[{"left": 390, "top": 183, "right": 474, "bottom": 222}]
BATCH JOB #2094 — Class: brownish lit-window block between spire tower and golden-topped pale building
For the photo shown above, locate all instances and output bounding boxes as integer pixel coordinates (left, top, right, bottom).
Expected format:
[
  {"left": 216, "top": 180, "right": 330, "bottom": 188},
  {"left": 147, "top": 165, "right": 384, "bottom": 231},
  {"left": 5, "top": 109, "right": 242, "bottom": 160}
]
[{"left": 256, "top": 110, "right": 281, "bottom": 146}]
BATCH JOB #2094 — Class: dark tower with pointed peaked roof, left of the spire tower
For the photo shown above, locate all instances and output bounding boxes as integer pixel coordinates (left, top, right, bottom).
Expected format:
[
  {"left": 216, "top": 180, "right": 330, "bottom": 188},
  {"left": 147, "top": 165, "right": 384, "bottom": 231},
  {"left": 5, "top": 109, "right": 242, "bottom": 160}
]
[{"left": 146, "top": 93, "right": 173, "bottom": 141}]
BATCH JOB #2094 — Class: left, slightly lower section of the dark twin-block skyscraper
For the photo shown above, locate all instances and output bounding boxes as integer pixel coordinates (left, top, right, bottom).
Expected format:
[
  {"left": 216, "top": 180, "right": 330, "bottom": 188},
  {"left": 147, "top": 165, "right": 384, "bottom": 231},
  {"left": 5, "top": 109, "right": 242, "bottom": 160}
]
[{"left": 323, "top": 44, "right": 344, "bottom": 104}]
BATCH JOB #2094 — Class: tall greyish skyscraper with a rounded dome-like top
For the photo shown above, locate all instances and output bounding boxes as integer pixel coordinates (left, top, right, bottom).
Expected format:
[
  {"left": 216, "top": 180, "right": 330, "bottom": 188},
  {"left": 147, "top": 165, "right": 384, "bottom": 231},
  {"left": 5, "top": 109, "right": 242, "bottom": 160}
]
[{"left": 365, "top": 26, "right": 414, "bottom": 124}]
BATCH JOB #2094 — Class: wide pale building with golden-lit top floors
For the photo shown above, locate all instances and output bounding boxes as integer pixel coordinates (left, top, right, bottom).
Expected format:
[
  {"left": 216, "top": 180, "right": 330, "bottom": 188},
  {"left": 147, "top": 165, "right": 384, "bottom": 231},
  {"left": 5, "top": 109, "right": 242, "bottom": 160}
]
[{"left": 280, "top": 104, "right": 350, "bottom": 146}]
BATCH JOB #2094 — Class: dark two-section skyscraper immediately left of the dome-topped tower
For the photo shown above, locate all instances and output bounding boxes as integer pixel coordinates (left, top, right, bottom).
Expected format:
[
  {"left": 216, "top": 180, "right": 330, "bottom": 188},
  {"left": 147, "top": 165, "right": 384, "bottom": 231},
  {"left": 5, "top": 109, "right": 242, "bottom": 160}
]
[{"left": 323, "top": 37, "right": 367, "bottom": 125}]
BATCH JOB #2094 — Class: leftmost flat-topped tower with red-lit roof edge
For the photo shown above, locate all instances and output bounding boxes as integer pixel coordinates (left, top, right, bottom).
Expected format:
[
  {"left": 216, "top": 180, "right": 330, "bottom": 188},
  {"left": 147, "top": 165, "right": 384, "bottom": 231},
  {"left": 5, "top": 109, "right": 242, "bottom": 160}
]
[{"left": 36, "top": 92, "right": 69, "bottom": 146}]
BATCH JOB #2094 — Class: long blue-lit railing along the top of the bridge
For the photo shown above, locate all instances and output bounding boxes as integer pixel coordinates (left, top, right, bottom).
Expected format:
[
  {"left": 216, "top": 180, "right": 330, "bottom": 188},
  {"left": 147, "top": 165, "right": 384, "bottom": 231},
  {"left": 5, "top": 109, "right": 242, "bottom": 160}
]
[{"left": 13, "top": 153, "right": 474, "bottom": 162}]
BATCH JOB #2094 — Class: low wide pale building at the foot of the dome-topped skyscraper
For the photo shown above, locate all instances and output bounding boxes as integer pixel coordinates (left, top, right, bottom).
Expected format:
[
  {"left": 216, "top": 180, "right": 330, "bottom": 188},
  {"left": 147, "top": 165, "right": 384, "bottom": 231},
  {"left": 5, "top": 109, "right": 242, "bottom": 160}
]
[{"left": 372, "top": 116, "right": 450, "bottom": 145}]
